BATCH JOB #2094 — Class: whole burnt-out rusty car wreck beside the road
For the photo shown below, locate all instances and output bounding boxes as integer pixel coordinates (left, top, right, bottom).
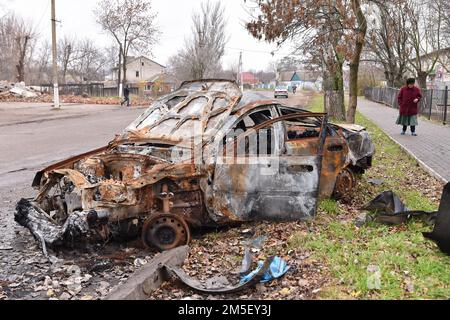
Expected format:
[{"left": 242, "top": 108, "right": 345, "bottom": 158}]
[{"left": 15, "top": 80, "right": 375, "bottom": 251}]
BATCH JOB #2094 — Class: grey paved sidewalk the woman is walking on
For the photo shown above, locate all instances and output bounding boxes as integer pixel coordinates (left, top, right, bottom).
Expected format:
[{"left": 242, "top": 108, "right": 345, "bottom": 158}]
[{"left": 358, "top": 99, "right": 450, "bottom": 182}]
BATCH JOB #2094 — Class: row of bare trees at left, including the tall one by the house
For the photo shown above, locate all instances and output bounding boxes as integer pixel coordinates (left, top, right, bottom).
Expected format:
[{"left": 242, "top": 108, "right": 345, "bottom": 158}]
[{"left": 0, "top": 0, "right": 158, "bottom": 84}]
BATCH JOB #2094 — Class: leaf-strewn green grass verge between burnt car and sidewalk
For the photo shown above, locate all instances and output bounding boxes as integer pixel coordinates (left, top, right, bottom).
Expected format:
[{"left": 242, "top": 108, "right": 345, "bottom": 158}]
[{"left": 289, "top": 97, "right": 450, "bottom": 299}]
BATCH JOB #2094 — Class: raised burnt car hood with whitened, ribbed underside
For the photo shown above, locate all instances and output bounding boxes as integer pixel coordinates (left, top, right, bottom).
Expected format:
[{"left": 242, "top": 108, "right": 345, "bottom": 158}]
[{"left": 119, "top": 79, "right": 242, "bottom": 144}]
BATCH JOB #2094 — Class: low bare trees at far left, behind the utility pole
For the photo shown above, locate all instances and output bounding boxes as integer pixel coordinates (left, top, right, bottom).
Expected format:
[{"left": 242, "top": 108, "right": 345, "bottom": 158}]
[{"left": 0, "top": 13, "right": 118, "bottom": 84}]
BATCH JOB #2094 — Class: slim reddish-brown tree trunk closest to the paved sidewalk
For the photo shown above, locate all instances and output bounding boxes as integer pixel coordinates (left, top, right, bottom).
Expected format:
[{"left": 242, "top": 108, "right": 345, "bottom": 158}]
[{"left": 347, "top": 0, "right": 367, "bottom": 123}]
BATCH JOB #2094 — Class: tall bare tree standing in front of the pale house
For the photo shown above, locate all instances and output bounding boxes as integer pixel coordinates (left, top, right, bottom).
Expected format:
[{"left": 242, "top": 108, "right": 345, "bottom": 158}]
[{"left": 94, "top": 0, "right": 158, "bottom": 85}]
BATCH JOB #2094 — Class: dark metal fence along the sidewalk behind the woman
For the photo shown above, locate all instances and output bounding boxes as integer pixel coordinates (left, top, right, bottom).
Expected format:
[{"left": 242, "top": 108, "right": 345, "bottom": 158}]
[{"left": 364, "top": 87, "right": 450, "bottom": 124}]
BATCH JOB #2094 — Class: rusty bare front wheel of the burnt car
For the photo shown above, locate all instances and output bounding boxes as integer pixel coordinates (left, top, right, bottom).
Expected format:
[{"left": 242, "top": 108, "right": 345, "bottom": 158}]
[{"left": 142, "top": 214, "right": 191, "bottom": 252}]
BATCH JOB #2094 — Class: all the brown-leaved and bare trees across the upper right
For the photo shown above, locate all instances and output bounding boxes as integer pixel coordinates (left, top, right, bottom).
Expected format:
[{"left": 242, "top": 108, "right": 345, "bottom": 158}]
[{"left": 244, "top": 0, "right": 450, "bottom": 123}]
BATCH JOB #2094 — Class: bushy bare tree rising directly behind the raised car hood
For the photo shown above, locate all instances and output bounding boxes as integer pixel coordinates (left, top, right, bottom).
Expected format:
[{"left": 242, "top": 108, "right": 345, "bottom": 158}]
[{"left": 169, "top": 0, "right": 228, "bottom": 79}]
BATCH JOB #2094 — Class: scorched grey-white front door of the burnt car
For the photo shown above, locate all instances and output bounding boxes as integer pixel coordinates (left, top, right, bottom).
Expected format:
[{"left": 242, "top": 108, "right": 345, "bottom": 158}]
[{"left": 213, "top": 106, "right": 325, "bottom": 223}]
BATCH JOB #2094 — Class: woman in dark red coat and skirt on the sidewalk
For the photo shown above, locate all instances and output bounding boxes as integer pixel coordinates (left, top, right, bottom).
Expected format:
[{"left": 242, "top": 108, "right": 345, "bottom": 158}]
[{"left": 397, "top": 79, "right": 422, "bottom": 137}]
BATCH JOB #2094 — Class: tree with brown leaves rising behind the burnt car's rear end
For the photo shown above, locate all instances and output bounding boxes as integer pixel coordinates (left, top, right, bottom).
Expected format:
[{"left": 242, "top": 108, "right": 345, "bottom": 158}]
[{"left": 247, "top": 0, "right": 358, "bottom": 122}]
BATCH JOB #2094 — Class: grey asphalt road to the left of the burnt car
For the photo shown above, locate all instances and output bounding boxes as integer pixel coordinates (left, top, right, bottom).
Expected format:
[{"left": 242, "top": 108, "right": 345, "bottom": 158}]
[{"left": 0, "top": 103, "right": 145, "bottom": 248}]
